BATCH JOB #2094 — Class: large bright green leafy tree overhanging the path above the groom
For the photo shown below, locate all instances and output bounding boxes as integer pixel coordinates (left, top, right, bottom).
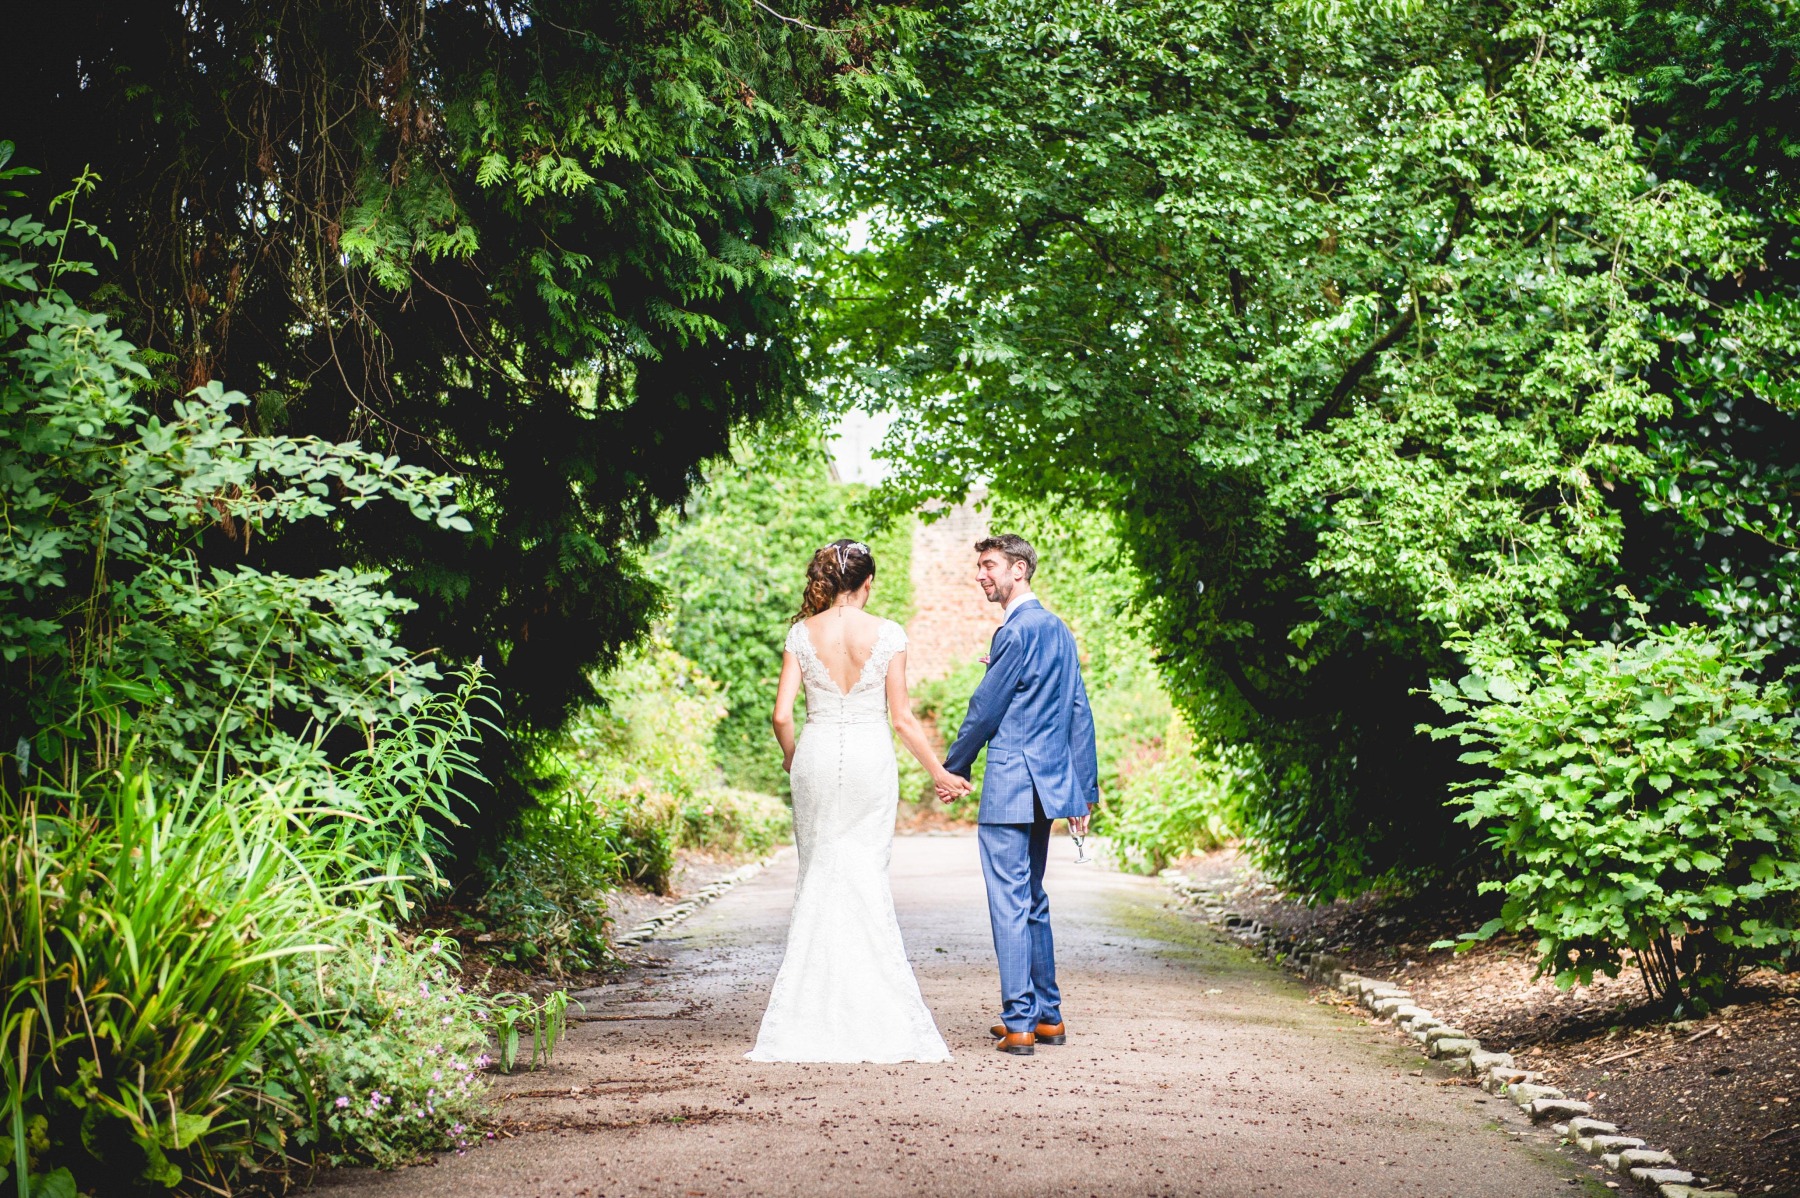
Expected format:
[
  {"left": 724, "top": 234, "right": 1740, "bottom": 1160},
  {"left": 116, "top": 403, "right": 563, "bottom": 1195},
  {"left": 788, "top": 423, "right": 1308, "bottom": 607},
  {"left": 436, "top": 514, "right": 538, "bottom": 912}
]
[{"left": 815, "top": 0, "right": 1795, "bottom": 896}]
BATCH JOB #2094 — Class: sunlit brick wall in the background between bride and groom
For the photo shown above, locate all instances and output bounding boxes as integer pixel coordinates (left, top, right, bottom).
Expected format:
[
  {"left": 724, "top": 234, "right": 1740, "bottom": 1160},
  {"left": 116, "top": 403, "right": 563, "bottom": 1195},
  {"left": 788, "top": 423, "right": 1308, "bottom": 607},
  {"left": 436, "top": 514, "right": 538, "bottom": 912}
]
[{"left": 905, "top": 493, "right": 1001, "bottom": 685}]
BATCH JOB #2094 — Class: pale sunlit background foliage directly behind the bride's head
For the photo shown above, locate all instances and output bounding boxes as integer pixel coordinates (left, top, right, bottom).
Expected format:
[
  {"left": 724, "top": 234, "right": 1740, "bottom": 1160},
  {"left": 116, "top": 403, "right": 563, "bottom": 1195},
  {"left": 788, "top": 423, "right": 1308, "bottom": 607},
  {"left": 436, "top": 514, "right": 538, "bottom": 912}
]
[{"left": 646, "top": 423, "right": 913, "bottom": 793}]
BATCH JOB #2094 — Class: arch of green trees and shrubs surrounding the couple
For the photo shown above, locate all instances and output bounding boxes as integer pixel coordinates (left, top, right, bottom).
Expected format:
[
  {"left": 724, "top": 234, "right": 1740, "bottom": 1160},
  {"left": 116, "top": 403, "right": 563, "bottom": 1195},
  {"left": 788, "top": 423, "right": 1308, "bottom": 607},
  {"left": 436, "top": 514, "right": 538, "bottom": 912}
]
[{"left": 0, "top": 0, "right": 1800, "bottom": 1184}]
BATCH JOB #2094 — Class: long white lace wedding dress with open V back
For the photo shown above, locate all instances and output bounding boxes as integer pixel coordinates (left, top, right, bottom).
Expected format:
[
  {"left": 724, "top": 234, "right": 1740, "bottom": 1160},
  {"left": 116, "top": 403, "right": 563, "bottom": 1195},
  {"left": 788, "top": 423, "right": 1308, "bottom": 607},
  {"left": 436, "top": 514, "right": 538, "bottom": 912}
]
[{"left": 745, "top": 621, "right": 950, "bottom": 1063}]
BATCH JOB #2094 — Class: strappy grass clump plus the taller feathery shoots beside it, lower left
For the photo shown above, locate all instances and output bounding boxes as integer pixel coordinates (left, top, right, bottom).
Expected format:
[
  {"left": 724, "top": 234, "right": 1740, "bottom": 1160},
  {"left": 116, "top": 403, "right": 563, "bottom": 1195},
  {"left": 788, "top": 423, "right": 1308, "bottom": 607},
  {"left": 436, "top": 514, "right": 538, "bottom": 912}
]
[{"left": 0, "top": 661, "right": 507, "bottom": 1194}]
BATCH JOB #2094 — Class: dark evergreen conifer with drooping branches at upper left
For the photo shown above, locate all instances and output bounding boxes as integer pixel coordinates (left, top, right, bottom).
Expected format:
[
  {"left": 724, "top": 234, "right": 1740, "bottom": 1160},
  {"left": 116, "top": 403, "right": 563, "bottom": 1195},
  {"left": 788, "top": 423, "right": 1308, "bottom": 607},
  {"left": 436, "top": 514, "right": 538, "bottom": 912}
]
[{"left": 0, "top": 0, "right": 916, "bottom": 827}]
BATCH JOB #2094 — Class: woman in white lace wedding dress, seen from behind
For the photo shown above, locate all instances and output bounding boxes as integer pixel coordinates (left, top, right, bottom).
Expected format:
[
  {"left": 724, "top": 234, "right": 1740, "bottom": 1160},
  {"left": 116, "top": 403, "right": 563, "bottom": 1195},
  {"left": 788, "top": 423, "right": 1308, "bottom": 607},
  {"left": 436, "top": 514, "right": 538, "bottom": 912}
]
[{"left": 747, "top": 541, "right": 968, "bottom": 1063}]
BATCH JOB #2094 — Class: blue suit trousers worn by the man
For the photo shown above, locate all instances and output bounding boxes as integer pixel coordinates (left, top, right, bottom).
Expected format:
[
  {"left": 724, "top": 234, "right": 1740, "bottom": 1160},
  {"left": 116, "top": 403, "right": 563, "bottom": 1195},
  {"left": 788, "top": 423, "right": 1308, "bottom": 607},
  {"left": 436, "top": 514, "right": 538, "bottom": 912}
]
[{"left": 977, "top": 799, "right": 1062, "bottom": 1031}]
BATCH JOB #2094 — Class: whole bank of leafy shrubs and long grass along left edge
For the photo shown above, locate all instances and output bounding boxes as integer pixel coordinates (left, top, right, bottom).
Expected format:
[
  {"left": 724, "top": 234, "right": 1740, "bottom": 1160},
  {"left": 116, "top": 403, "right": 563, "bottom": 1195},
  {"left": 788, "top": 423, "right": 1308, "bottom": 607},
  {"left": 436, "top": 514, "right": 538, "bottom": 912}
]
[{"left": 0, "top": 146, "right": 529, "bottom": 1193}]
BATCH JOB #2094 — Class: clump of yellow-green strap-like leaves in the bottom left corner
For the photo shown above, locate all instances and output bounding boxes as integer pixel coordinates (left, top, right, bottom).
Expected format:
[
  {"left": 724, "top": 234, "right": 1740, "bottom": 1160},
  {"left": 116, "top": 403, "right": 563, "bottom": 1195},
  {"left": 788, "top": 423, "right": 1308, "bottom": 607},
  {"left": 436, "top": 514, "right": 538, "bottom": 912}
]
[{"left": 0, "top": 773, "right": 373, "bottom": 1185}]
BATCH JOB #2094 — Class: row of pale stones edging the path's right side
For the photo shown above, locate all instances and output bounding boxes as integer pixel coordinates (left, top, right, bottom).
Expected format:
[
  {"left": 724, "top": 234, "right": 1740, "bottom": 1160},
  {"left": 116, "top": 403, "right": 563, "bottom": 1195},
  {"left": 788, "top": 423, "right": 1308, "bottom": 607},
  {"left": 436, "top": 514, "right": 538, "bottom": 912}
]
[{"left": 1161, "top": 869, "right": 1737, "bottom": 1198}]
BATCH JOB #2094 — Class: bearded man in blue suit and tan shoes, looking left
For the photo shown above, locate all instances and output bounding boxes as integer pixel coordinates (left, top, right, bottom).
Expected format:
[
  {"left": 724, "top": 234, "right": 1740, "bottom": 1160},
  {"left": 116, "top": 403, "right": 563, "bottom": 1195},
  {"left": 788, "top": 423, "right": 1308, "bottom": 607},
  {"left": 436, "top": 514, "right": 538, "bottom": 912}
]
[{"left": 938, "top": 532, "right": 1100, "bottom": 1056}]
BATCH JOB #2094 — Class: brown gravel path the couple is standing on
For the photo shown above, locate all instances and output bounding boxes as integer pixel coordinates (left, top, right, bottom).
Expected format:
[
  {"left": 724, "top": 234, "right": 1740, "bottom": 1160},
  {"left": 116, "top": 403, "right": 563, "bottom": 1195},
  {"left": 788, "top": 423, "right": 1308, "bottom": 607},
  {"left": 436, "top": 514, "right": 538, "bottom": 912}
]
[{"left": 302, "top": 836, "right": 1606, "bottom": 1198}]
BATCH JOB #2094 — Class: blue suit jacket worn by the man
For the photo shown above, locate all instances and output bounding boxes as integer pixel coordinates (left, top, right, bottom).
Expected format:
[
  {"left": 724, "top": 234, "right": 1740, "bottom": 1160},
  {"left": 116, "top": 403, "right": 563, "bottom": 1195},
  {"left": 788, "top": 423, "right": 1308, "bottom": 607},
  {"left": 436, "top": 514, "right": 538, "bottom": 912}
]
[{"left": 943, "top": 599, "right": 1100, "bottom": 824}]
